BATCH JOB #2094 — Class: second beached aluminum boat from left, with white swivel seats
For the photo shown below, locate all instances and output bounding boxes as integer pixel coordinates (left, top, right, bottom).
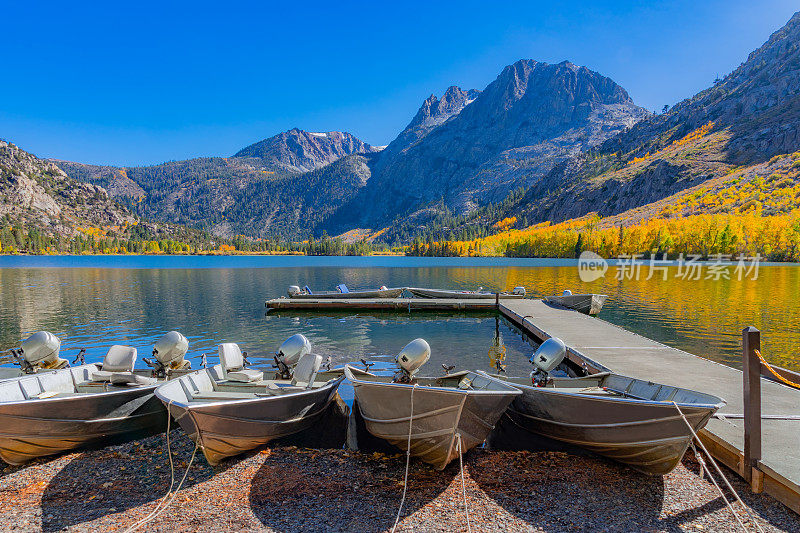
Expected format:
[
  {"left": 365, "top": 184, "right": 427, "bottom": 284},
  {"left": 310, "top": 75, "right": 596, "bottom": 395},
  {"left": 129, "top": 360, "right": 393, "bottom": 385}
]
[{"left": 156, "top": 334, "right": 344, "bottom": 465}]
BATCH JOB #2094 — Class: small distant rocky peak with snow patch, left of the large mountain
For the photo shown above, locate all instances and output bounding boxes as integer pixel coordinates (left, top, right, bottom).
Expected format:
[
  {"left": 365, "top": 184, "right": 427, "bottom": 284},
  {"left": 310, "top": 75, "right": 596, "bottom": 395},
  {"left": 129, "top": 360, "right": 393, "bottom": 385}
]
[{"left": 233, "top": 128, "right": 379, "bottom": 172}]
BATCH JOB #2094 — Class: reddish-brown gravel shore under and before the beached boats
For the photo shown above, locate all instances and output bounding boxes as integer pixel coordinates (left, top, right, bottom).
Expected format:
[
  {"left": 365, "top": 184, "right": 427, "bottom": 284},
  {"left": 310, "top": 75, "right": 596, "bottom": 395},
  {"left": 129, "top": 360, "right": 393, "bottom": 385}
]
[{"left": 0, "top": 430, "right": 800, "bottom": 532}]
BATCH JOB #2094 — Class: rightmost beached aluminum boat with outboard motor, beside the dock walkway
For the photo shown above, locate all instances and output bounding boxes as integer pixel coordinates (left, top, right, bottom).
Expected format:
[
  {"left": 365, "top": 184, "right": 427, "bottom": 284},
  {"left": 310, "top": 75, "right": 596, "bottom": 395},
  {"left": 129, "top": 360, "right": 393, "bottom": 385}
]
[{"left": 484, "top": 338, "right": 725, "bottom": 475}]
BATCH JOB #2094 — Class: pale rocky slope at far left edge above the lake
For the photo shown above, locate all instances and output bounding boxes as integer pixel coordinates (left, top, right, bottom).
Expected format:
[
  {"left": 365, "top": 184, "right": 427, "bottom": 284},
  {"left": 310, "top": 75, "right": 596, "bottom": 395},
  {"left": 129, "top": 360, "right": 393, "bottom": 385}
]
[{"left": 0, "top": 140, "right": 135, "bottom": 235}]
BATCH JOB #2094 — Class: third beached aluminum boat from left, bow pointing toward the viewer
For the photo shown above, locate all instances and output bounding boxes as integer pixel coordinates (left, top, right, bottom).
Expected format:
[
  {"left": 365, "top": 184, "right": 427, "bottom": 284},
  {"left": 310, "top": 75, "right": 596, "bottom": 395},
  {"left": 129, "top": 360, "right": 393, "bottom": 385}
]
[{"left": 345, "top": 339, "right": 521, "bottom": 470}]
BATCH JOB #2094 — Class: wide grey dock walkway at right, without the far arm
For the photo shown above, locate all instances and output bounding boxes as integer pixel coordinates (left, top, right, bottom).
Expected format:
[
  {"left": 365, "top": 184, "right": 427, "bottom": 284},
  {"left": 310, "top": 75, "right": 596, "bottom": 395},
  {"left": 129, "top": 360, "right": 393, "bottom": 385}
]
[{"left": 500, "top": 300, "right": 800, "bottom": 512}]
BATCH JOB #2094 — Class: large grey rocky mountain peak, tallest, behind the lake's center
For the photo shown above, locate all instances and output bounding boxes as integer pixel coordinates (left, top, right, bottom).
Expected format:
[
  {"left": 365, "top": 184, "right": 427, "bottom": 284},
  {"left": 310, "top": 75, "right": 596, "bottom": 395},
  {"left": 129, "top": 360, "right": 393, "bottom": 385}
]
[{"left": 333, "top": 60, "right": 647, "bottom": 231}]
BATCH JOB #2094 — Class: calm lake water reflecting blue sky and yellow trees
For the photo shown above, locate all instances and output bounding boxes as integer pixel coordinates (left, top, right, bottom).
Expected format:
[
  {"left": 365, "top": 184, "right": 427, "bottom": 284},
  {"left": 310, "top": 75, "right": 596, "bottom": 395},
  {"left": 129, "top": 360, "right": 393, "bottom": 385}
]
[{"left": 0, "top": 256, "right": 800, "bottom": 384}]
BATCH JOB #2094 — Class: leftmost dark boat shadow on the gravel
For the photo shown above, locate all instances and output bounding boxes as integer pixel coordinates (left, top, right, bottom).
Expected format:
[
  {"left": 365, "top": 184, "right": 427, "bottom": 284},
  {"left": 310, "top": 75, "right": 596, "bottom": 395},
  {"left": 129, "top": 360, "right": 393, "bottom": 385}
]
[{"left": 41, "top": 428, "right": 219, "bottom": 531}]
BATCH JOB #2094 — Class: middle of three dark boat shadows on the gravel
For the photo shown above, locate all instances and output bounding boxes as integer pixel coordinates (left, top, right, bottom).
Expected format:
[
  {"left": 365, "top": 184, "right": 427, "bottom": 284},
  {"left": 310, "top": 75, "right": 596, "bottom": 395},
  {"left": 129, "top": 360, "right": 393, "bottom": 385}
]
[{"left": 249, "top": 450, "right": 458, "bottom": 533}]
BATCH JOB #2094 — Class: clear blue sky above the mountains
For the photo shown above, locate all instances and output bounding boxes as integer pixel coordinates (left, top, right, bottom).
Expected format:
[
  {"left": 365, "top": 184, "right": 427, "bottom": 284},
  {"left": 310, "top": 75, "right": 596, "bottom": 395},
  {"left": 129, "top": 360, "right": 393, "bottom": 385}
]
[{"left": 0, "top": 0, "right": 800, "bottom": 165}]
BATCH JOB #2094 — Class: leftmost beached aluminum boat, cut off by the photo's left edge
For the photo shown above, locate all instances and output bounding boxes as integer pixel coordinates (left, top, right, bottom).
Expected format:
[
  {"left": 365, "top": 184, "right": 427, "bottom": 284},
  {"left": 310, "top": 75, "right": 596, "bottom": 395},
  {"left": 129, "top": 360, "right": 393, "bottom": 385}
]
[{"left": 0, "top": 331, "right": 190, "bottom": 464}]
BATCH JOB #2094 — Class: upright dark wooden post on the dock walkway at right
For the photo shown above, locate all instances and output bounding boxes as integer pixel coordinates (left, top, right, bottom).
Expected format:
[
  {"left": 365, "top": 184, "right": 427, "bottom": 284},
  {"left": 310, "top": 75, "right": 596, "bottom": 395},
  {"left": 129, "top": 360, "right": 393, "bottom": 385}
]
[{"left": 741, "top": 326, "right": 763, "bottom": 492}]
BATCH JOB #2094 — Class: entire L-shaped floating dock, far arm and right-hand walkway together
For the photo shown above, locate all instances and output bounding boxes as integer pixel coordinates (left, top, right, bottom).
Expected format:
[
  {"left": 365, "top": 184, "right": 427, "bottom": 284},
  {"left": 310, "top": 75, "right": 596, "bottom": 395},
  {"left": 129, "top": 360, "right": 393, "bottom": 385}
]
[{"left": 266, "top": 298, "right": 800, "bottom": 513}]
